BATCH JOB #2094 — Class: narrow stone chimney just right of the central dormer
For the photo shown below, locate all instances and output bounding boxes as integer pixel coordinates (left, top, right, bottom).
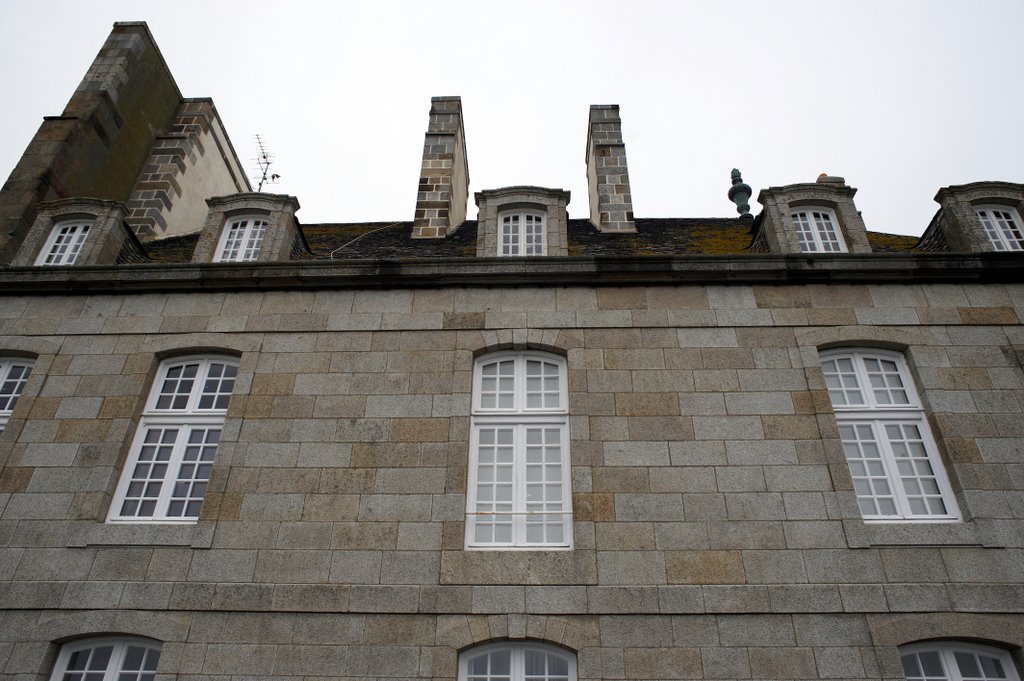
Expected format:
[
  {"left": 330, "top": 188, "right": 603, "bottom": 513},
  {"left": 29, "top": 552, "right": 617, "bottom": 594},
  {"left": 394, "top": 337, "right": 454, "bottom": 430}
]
[{"left": 587, "top": 104, "right": 636, "bottom": 231}]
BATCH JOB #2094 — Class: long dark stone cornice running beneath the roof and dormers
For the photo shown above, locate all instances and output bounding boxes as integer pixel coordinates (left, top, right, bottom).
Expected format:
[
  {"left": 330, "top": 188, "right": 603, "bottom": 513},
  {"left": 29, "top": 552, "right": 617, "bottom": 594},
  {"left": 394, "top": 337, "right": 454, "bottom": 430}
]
[{"left": 0, "top": 253, "right": 1024, "bottom": 295}]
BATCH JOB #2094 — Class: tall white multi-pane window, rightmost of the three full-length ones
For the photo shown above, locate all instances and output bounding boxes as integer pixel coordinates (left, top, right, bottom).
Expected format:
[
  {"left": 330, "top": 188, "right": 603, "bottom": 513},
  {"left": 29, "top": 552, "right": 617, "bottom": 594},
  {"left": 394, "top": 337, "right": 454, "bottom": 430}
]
[{"left": 821, "top": 350, "right": 957, "bottom": 520}]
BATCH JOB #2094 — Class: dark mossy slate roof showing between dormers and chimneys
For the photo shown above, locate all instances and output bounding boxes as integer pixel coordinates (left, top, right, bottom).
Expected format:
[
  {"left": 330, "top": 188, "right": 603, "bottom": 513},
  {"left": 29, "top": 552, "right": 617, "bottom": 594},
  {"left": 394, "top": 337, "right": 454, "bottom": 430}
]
[{"left": 138, "top": 217, "right": 918, "bottom": 262}]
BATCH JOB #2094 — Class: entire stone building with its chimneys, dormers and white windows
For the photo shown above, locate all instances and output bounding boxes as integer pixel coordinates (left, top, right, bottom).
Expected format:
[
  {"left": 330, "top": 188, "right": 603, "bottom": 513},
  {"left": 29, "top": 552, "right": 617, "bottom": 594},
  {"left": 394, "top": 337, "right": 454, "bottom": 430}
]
[{"left": 0, "top": 25, "right": 1024, "bottom": 681}]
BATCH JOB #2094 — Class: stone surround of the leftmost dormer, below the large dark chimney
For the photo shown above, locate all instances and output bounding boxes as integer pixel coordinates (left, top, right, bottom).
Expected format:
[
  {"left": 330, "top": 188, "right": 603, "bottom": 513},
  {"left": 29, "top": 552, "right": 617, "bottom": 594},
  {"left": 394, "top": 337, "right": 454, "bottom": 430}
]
[{"left": 10, "top": 199, "right": 129, "bottom": 267}]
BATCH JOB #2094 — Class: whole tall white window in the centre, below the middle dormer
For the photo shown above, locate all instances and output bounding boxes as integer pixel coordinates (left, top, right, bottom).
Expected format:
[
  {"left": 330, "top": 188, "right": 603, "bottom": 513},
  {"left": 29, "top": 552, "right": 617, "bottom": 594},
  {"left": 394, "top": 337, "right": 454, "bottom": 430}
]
[{"left": 466, "top": 352, "right": 572, "bottom": 548}]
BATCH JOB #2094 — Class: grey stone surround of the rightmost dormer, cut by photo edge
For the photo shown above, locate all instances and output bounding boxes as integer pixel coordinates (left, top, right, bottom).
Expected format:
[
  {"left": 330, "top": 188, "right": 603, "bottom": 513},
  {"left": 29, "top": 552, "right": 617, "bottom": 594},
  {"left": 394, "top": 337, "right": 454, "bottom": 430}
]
[{"left": 922, "top": 182, "right": 1024, "bottom": 253}]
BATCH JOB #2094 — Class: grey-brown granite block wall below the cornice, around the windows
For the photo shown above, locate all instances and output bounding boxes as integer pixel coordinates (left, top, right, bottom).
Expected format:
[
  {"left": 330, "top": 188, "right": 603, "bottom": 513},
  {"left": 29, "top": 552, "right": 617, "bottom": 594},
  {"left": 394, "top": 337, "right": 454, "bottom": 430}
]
[{"left": 0, "top": 284, "right": 1024, "bottom": 679}]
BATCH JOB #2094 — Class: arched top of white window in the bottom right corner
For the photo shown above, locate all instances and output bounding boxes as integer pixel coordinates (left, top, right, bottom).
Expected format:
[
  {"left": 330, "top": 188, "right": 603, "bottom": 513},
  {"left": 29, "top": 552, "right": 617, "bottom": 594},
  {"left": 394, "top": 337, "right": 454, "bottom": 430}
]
[{"left": 900, "top": 641, "right": 1020, "bottom": 681}]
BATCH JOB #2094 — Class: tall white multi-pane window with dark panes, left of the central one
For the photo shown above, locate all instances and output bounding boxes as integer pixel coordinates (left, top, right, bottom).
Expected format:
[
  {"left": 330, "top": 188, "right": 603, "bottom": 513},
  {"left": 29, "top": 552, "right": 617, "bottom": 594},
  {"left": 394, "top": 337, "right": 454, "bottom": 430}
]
[{"left": 110, "top": 357, "right": 238, "bottom": 522}]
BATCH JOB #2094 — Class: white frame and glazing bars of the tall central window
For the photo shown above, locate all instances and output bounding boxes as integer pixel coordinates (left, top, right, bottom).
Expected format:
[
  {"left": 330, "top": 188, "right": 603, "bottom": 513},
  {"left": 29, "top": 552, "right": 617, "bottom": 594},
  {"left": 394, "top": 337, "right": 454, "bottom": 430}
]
[{"left": 465, "top": 352, "right": 572, "bottom": 550}]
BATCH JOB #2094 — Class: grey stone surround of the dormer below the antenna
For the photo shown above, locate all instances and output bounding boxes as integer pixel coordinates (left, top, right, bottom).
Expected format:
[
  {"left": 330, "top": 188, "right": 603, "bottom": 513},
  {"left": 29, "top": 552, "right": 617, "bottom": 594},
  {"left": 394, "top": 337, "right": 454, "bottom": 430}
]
[{"left": 193, "top": 193, "right": 305, "bottom": 262}]
